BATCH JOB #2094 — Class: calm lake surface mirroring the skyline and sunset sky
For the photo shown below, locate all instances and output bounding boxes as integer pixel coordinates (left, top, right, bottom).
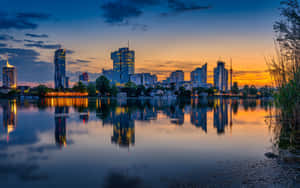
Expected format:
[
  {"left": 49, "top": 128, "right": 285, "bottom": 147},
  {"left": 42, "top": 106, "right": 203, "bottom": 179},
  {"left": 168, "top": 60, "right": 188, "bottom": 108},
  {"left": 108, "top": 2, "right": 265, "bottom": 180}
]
[{"left": 0, "top": 99, "right": 299, "bottom": 188}]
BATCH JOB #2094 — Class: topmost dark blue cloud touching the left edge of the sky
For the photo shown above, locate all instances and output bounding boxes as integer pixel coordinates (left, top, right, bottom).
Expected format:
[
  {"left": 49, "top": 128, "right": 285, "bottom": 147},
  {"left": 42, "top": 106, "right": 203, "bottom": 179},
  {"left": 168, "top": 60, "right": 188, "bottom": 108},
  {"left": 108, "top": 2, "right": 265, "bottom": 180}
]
[{"left": 0, "top": 12, "right": 50, "bottom": 30}]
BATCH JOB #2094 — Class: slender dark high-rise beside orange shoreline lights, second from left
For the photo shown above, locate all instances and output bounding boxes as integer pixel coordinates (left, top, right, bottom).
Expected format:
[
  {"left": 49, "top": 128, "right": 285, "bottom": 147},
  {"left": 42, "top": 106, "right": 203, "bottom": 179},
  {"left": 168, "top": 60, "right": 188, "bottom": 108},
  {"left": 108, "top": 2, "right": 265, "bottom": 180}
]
[{"left": 54, "top": 49, "right": 69, "bottom": 89}]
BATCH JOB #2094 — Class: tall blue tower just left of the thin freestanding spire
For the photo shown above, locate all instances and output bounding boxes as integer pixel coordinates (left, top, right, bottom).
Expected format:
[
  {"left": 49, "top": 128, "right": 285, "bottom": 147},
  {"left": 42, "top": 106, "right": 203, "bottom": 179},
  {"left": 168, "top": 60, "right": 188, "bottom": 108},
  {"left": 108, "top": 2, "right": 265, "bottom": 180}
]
[{"left": 214, "top": 61, "right": 228, "bottom": 92}]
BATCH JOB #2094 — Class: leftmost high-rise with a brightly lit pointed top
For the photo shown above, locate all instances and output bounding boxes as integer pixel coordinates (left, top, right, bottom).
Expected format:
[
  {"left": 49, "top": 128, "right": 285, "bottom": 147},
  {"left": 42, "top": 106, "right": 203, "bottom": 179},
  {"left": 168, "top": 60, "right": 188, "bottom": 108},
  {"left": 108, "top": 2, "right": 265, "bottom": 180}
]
[{"left": 2, "top": 60, "right": 17, "bottom": 89}]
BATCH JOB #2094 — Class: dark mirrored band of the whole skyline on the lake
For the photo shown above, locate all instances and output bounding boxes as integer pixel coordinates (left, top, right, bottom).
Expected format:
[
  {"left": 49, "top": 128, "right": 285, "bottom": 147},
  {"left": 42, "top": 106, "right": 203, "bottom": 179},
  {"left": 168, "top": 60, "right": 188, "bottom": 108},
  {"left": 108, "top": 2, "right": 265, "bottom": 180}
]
[{"left": 1, "top": 98, "right": 272, "bottom": 147}]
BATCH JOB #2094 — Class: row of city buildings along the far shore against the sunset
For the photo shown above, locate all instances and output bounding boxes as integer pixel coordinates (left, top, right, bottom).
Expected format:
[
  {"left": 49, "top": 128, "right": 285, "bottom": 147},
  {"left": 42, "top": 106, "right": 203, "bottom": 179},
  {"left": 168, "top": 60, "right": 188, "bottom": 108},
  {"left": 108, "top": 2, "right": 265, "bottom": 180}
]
[{"left": 2, "top": 49, "right": 262, "bottom": 89}]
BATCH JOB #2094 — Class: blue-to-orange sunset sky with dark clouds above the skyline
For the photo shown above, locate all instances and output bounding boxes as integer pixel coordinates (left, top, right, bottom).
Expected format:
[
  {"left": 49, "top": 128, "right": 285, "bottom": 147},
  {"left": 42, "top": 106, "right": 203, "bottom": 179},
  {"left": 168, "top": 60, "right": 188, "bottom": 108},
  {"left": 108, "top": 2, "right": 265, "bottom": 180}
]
[{"left": 0, "top": 0, "right": 280, "bottom": 86}]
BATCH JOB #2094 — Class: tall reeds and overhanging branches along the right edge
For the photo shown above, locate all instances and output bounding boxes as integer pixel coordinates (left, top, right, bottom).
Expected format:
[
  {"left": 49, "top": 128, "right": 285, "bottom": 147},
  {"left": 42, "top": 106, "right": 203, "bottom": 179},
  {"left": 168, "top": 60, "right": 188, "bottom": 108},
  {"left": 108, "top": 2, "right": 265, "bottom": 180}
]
[{"left": 267, "top": 0, "right": 300, "bottom": 154}]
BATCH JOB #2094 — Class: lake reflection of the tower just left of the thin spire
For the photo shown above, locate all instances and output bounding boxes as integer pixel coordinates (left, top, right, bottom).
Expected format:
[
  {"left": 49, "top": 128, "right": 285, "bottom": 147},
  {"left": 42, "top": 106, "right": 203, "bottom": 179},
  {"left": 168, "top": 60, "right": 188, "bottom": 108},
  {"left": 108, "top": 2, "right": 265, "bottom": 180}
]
[{"left": 214, "top": 99, "right": 228, "bottom": 134}]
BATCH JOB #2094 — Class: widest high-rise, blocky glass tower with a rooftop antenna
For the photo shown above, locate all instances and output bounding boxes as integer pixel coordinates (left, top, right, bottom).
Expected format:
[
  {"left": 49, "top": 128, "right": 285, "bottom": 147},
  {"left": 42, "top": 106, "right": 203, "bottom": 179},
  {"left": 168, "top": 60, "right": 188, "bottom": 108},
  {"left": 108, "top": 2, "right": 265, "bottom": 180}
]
[{"left": 111, "top": 48, "right": 135, "bottom": 83}]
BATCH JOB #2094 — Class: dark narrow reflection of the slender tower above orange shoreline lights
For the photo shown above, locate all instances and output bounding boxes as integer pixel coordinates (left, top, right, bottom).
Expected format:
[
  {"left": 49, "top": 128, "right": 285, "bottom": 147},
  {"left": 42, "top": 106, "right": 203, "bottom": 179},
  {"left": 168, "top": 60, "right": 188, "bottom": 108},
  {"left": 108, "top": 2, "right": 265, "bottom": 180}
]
[{"left": 55, "top": 106, "right": 69, "bottom": 147}]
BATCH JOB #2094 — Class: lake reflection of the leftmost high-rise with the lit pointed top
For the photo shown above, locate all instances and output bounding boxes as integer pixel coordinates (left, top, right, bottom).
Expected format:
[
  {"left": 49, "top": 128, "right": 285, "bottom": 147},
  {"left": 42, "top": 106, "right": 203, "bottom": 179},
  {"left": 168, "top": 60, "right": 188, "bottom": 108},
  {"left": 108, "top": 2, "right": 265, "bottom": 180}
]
[{"left": 2, "top": 100, "right": 17, "bottom": 142}]
